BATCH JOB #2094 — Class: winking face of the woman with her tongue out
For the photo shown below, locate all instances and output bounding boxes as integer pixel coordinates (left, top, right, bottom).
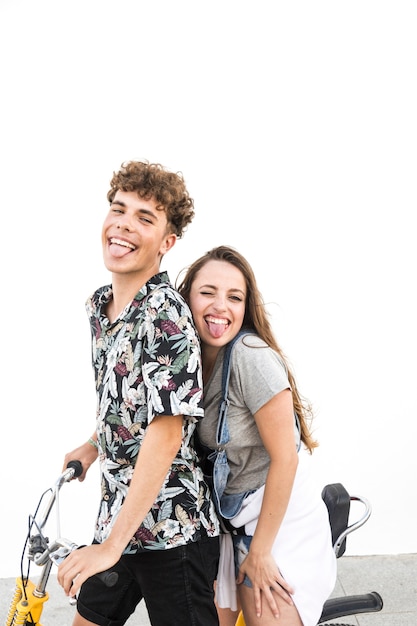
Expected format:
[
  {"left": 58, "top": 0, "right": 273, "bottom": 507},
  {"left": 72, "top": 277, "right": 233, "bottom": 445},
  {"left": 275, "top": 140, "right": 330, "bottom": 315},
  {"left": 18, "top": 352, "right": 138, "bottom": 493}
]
[{"left": 190, "top": 261, "right": 246, "bottom": 348}]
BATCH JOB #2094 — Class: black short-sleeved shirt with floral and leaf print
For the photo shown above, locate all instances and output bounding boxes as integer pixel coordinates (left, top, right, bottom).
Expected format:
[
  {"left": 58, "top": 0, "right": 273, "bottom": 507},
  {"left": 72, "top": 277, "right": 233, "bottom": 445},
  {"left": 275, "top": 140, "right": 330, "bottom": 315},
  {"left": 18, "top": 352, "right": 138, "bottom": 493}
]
[{"left": 86, "top": 272, "right": 219, "bottom": 554}]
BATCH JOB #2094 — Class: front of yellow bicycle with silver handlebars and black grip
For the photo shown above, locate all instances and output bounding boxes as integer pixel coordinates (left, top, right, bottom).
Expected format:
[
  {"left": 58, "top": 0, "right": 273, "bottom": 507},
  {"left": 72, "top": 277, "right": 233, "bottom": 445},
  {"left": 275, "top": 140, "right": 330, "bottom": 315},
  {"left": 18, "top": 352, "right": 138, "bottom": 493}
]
[{"left": 5, "top": 461, "right": 118, "bottom": 626}]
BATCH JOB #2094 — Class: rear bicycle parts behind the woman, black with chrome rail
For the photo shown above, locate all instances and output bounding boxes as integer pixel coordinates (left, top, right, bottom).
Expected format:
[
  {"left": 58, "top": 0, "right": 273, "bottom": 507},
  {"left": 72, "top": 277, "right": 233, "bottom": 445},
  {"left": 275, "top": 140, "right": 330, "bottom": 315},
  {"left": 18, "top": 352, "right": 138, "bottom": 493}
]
[{"left": 232, "top": 483, "right": 383, "bottom": 626}]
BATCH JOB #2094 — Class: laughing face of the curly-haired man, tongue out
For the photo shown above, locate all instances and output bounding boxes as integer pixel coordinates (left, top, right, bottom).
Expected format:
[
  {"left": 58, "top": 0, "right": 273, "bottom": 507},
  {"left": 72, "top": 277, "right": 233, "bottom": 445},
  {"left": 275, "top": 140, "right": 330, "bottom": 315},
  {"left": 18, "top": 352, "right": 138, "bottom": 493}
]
[{"left": 102, "top": 190, "right": 176, "bottom": 280}]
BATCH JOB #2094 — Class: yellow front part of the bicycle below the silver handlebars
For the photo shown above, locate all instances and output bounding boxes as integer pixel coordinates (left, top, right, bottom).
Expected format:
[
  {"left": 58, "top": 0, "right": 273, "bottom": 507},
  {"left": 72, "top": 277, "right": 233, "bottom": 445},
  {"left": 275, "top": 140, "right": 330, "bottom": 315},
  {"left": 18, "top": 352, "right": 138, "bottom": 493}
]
[{"left": 6, "top": 578, "right": 49, "bottom": 626}]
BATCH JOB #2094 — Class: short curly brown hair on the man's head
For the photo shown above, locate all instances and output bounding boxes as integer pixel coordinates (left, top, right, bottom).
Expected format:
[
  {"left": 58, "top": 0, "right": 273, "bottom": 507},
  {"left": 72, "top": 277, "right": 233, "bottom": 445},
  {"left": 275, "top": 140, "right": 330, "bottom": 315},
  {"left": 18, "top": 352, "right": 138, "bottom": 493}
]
[{"left": 107, "top": 161, "right": 194, "bottom": 239}]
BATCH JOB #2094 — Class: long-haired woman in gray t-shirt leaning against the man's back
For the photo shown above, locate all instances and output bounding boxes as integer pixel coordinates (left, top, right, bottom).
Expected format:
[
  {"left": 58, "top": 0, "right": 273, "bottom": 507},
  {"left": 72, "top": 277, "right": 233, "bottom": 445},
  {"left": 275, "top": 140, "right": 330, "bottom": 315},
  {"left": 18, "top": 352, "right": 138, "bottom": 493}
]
[{"left": 179, "top": 246, "right": 336, "bottom": 626}]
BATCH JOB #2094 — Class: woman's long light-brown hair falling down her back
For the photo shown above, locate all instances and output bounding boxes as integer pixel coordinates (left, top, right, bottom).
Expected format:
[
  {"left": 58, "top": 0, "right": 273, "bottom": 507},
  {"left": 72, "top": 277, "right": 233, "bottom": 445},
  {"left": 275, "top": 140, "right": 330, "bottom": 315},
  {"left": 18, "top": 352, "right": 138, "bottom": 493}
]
[{"left": 178, "top": 241, "right": 318, "bottom": 452}]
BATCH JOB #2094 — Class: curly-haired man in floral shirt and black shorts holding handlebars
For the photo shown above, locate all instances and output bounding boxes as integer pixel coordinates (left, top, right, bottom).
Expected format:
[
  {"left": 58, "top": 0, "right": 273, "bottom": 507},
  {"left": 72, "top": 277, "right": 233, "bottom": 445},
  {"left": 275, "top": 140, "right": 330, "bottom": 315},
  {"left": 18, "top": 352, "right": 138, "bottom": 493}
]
[{"left": 58, "top": 161, "right": 219, "bottom": 626}]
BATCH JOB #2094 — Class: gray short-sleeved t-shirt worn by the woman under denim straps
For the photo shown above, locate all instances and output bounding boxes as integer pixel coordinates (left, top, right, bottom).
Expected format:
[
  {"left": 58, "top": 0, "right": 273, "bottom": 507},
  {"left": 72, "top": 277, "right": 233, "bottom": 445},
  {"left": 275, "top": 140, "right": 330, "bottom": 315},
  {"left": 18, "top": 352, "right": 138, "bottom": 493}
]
[{"left": 198, "top": 335, "right": 298, "bottom": 494}]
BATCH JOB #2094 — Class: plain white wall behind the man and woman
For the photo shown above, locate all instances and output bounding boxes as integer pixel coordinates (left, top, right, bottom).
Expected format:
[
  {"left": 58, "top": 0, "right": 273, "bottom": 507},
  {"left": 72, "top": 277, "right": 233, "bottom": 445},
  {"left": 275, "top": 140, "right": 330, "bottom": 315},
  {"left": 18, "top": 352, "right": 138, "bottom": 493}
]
[{"left": 0, "top": 0, "right": 417, "bottom": 576}]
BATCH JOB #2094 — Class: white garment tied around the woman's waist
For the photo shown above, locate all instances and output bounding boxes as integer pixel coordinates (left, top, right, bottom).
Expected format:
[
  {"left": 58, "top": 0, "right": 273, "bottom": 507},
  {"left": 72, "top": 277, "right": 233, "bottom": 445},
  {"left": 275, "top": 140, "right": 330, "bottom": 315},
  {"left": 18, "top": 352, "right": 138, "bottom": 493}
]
[{"left": 217, "top": 450, "right": 337, "bottom": 626}]
